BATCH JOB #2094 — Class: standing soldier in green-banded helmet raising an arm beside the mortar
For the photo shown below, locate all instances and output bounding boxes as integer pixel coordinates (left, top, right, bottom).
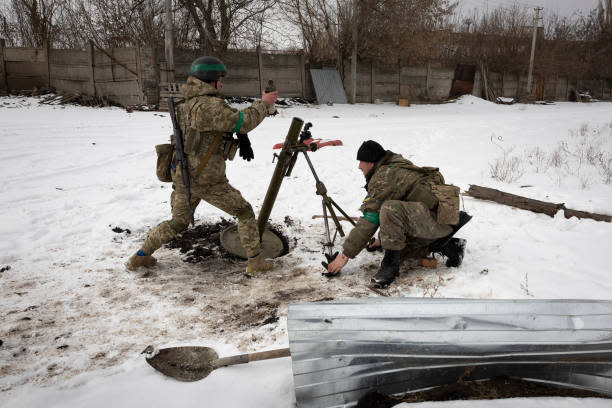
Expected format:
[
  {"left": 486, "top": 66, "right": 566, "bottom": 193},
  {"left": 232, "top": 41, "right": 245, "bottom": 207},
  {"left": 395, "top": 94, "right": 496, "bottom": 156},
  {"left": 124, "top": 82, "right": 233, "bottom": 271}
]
[{"left": 126, "top": 57, "right": 278, "bottom": 276}]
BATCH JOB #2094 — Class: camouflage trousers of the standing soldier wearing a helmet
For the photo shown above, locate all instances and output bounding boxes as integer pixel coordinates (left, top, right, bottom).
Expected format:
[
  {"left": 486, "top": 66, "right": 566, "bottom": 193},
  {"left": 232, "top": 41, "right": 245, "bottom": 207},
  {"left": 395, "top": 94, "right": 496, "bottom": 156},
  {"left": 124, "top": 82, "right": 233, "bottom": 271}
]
[{"left": 141, "top": 155, "right": 261, "bottom": 258}]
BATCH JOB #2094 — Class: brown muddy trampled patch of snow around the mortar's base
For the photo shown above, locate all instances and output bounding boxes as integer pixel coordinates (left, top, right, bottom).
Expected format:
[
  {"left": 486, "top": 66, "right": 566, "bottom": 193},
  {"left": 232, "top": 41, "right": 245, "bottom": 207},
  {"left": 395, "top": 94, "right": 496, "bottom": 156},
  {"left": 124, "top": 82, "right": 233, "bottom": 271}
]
[{"left": 0, "top": 217, "right": 460, "bottom": 392}]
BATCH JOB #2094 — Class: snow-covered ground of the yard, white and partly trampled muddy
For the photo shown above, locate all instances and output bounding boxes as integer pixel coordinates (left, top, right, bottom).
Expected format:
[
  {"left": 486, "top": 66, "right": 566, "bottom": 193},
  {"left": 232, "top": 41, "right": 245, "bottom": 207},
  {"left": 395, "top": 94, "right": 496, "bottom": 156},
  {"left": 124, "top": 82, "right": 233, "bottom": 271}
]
[{"left": 0, "top": 97, "right": 612, "bottom": 407}]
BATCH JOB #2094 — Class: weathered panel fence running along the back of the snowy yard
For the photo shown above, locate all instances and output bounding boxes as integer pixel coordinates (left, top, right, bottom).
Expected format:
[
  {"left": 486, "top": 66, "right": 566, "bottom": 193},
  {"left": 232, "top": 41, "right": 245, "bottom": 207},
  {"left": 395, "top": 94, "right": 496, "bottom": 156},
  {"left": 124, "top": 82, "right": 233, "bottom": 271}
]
[{"left": 0, "top": 39, "right": 612, "bottom": 106}]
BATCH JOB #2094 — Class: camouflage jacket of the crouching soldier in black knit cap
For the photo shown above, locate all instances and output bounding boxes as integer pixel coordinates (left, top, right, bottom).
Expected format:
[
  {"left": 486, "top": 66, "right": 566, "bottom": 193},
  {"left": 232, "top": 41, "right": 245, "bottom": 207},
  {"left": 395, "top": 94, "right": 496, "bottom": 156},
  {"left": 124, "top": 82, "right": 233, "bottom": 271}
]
[{"left": 343, "top": 150, "right": 444, "bottom": 258}]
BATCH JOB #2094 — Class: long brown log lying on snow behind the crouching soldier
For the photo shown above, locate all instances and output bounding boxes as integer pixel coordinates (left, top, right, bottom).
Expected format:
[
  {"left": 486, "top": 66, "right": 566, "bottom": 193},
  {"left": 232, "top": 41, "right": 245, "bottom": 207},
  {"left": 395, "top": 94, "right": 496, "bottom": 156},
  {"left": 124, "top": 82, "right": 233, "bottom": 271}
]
[{"left": 463, "top": 184, "right": 612, "bottom": 222}]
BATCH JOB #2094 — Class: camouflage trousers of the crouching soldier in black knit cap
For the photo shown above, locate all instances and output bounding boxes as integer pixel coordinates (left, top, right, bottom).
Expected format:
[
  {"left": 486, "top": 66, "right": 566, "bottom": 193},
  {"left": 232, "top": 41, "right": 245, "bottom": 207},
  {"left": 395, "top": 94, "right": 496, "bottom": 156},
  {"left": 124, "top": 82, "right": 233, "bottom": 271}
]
[{"left": 380, "top": 200, "right": 452, "bottom": 258}]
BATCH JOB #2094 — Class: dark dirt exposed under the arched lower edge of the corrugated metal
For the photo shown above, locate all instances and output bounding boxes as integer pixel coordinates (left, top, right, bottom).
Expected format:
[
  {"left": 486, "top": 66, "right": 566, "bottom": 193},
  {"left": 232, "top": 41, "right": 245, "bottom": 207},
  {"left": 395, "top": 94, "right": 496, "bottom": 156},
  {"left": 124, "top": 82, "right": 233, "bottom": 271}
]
[{"left": 357, "top": 377, "right": 610, "bottom": 408}]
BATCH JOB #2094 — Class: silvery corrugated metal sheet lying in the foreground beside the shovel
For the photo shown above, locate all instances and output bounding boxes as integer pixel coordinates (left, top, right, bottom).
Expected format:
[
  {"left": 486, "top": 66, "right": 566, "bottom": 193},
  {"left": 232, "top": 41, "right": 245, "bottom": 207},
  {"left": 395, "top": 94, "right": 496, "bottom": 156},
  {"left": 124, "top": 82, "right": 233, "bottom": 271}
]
[{"left": 287, "top": 298, "right": 612, "bottom": 408}]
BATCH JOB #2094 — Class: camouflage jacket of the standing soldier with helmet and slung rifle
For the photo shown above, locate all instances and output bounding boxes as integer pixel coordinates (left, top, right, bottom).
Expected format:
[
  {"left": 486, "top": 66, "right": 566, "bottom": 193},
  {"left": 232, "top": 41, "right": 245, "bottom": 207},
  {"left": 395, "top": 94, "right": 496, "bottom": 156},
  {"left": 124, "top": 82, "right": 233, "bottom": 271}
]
[{"left": 176, "top": 76, "right": 268, "bottom": 184}]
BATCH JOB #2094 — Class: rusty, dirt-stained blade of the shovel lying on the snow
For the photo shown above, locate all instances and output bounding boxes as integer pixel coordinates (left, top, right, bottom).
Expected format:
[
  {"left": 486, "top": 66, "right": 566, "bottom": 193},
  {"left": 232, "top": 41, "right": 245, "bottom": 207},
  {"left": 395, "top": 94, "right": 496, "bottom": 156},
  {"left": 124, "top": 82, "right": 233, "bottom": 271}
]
[{"left": 146, "top": 346, "right": 219, "bottom": 382}]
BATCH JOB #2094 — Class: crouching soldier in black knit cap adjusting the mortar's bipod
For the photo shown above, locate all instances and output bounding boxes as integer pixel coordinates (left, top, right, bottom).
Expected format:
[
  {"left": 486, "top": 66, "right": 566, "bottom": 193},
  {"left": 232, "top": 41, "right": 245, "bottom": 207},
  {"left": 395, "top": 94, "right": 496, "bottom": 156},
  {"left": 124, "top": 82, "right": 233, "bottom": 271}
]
[{"left": 327, "top": 140, "right": 469, "bottom": 287}]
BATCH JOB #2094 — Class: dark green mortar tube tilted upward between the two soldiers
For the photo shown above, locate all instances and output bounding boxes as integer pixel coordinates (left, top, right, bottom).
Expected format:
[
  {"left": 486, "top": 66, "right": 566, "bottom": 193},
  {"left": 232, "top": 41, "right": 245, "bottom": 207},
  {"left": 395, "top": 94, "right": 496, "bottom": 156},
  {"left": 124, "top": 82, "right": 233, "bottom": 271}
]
[{"left": 257, "top": 118, "right": 304, "bottom": 240}]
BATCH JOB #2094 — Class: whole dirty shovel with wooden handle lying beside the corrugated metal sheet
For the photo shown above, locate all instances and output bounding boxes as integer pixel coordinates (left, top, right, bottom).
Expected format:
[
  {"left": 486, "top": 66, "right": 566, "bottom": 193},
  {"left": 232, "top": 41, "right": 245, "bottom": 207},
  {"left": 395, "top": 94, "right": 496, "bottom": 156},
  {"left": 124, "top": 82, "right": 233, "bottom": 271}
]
[{"left": 142, "top": 346, "right": 291, "bottom": 382}]
